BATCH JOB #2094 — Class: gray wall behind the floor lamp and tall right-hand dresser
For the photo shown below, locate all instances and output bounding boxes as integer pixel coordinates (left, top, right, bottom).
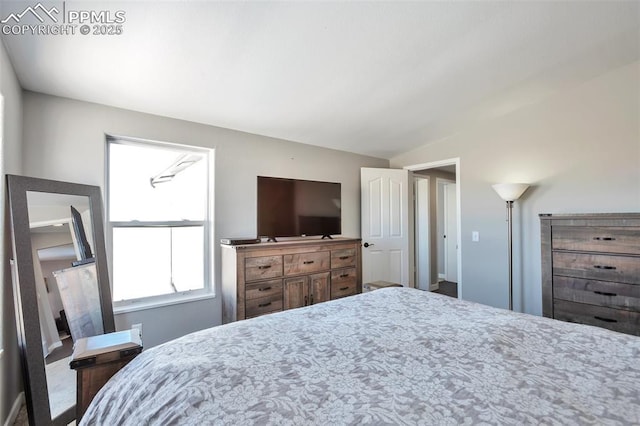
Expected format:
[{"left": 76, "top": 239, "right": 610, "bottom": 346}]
[{"left": 391, "top": 62, "right": 640, "bottom": 315}]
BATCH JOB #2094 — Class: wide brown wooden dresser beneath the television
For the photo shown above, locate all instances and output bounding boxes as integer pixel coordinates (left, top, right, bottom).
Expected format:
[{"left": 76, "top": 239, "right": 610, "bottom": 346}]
[{"left": 222, "top": 238, "right": 362, "bottom": 323}]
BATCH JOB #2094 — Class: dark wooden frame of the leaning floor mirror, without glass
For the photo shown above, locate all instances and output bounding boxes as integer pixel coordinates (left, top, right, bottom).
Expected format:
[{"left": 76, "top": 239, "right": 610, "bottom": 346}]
[{"left": 7, "top": 175, "right": 115, "bottom": 425}]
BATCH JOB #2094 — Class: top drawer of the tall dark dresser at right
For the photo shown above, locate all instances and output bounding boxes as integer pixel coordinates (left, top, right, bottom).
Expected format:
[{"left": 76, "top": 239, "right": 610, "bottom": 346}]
[{"left": 552, "top": 226, "right": 640, "bottom": 254}]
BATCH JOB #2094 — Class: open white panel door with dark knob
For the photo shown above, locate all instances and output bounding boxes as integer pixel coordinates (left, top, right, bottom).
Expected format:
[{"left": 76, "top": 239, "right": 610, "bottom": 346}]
[{"left": 360, "top": 168, "right": 413, "bottom": 287}]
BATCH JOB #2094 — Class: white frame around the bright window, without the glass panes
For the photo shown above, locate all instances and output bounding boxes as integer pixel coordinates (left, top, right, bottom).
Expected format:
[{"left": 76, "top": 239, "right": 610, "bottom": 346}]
[{"left": 105, "top": 134, "right": 216, "bottom": 314}]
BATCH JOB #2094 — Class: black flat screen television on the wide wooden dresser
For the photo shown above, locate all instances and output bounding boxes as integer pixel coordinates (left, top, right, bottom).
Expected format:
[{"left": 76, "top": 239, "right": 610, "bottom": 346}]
[{"left": 258, "top": 176, "right": 342, "bottom": 241}]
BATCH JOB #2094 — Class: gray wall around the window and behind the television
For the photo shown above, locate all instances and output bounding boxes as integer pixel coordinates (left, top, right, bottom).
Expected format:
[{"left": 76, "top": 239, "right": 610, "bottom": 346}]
[{"left": 23, "top": 92, "right": 389, "bottom": 347}]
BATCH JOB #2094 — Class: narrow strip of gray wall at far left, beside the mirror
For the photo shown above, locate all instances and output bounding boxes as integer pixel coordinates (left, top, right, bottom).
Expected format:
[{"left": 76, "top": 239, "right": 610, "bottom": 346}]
[{"left": 0, "top": 38, "right": 22, "bottom": 424}]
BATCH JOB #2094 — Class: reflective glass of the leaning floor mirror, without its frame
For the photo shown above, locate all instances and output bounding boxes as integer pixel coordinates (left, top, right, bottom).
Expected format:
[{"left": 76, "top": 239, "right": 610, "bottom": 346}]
[{"left": 27, "top": 191, "right": 104, "bottom": 418}]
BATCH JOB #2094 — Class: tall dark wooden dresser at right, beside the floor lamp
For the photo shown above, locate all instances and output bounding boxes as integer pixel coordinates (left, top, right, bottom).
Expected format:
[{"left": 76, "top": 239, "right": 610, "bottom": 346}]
[{"left": 540, "top": 213, "right": 640, "bottom": 335}]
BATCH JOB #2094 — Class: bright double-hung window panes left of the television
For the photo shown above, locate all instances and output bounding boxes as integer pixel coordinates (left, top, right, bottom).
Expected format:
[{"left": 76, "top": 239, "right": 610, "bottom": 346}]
[{"left": 107, "top": 136, "right": 213, "bottom": 307}]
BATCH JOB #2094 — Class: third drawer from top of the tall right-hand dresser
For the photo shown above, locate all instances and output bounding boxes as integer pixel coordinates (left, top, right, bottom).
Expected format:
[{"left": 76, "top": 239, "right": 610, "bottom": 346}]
[{"left": 553, "top": 276, "right": 640, "bottom": 312}]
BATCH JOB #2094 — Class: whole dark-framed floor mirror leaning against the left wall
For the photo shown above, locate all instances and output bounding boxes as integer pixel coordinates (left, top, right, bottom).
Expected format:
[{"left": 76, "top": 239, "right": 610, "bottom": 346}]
[{"left": 7, "top": 175, "right": 115, "bottom": 425}]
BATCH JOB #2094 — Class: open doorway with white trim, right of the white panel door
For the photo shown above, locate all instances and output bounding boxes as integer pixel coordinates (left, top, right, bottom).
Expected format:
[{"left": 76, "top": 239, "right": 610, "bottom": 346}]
[{"left": 406, "top": 158, "right": 462, "bottom": 298}]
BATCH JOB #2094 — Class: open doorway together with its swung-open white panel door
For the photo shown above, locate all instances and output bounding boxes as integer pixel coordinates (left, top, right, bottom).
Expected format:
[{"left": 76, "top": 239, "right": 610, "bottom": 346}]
[{"left": 360, "top": 158, "right": 463, "bottom": 298}]
